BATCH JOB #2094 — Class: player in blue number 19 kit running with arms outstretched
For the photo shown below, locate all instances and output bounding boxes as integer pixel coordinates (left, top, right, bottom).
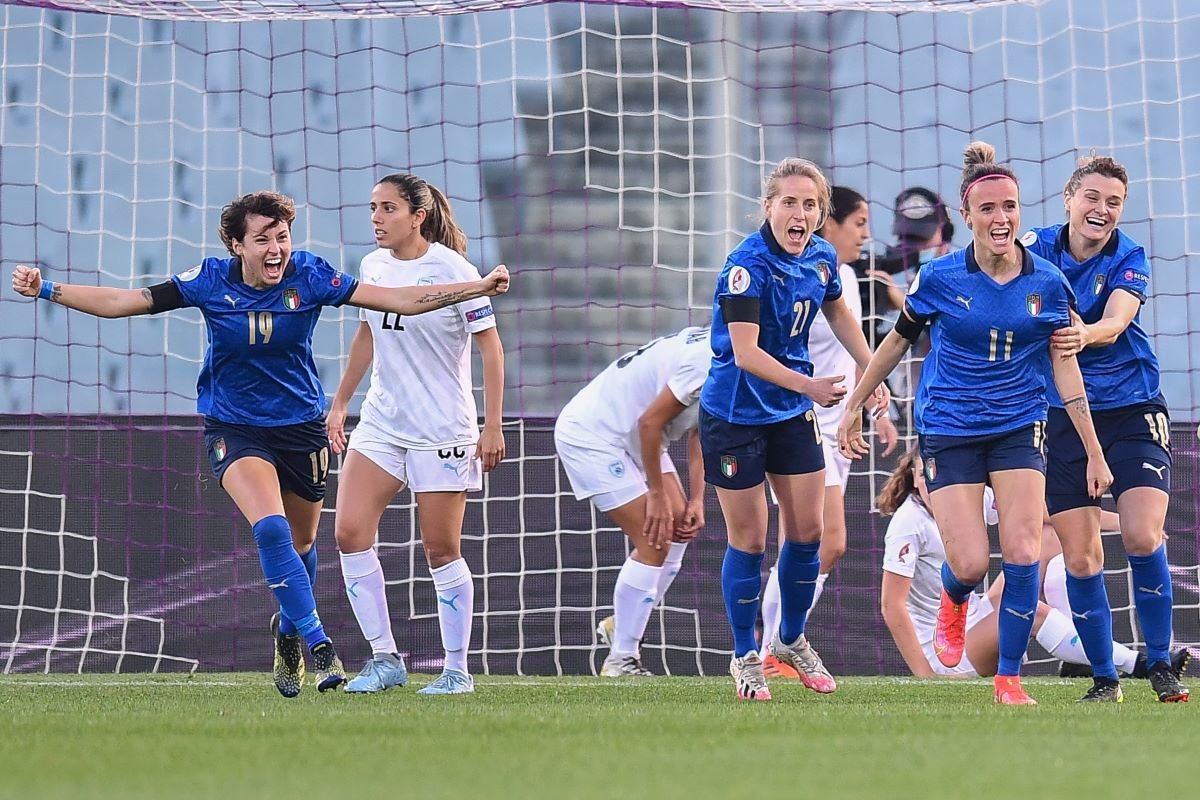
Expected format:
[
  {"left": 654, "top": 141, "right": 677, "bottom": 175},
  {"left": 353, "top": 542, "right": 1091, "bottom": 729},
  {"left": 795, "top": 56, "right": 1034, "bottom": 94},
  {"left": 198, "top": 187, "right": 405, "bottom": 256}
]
[{"left": 12, "top": 192, "right": 509, "bottom": 697}]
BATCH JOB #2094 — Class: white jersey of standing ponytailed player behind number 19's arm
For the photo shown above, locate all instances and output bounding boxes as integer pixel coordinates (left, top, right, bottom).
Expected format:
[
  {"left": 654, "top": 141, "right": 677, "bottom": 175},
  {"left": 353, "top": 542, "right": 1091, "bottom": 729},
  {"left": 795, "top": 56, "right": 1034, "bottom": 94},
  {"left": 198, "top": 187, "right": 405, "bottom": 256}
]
[{"left": 359, "top": 242, "right": 496, "bottom": 450}]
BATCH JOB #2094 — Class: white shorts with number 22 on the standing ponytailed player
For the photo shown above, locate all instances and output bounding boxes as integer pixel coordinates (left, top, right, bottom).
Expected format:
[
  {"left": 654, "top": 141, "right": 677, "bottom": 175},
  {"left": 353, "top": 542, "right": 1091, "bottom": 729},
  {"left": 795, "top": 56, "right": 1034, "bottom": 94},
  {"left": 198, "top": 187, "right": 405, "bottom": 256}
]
[{"left": 347, "top": 425, "right": 484, "bottom": 492}]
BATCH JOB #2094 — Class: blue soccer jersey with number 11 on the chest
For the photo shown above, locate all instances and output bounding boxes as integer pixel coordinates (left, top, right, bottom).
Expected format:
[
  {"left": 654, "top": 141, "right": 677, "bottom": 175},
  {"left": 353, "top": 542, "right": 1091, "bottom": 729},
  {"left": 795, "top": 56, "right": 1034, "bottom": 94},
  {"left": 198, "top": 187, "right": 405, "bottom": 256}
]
[{"left": 905, "top": 245, "right": 1074, "bottom": 437}]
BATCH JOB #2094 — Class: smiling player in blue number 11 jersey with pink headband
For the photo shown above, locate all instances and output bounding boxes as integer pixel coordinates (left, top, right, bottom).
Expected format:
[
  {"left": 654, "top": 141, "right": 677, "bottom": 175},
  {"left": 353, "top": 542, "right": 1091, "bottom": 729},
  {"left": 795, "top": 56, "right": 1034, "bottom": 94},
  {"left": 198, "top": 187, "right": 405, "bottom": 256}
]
[{"left": 838, "top": 142, "right": 1116, "bottom": 705}]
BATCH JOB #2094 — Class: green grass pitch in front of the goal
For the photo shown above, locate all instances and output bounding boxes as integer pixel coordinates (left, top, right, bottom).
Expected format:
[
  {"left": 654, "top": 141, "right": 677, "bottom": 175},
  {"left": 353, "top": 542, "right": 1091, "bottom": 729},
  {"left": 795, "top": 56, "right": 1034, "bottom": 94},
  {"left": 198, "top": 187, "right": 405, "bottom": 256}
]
[{"left": 0, "top": 674, "right": 1200, "bottom": 800}]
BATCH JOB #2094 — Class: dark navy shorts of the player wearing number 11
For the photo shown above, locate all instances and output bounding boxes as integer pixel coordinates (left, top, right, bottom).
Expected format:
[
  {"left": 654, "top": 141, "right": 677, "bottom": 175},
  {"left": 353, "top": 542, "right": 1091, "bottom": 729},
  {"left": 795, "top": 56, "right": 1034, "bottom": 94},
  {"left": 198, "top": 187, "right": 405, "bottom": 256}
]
[{"left": 918, "top": 422, "right": 1046, "bottom": 492}]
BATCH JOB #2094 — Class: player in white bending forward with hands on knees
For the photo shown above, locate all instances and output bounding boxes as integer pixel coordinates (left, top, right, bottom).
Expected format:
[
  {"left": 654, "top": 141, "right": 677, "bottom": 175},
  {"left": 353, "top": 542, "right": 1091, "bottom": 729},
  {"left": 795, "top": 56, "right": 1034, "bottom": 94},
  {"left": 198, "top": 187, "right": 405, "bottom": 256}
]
[{"left": 554, "top": 327, "right": 713, "bottom": 678}]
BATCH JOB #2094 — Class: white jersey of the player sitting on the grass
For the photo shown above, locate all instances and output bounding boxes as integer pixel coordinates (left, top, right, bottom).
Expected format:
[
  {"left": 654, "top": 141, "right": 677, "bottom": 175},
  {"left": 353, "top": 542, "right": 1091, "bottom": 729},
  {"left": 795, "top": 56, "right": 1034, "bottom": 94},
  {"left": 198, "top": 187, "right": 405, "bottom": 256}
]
[{"left": 883, "top": 487, "right": 997, "bottom": 646}]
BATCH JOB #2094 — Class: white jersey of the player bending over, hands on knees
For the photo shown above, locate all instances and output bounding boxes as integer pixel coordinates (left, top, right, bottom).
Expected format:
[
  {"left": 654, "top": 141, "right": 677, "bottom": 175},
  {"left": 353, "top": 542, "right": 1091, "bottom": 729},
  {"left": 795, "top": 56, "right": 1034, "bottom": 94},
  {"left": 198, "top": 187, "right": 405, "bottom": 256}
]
[{"left": 557, "top": 327, "right": 713, "bottom": 457}]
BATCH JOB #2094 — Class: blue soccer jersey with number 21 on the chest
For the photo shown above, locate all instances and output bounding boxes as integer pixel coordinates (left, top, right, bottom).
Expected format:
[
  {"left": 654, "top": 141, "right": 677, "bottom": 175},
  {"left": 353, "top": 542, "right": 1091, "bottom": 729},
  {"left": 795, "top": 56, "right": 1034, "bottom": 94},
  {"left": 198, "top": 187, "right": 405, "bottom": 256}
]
[{"left": 700, "top": 223, "right": 841, "bottom": 425}]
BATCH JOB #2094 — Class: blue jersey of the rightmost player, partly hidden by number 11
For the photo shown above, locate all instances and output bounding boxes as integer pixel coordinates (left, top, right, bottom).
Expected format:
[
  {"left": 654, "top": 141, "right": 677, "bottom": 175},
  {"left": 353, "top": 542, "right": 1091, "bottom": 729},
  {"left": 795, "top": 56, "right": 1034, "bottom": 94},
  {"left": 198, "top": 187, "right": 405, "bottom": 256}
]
[{"left": 1021, "top": 224, "right": 1159, "bottom": 411}]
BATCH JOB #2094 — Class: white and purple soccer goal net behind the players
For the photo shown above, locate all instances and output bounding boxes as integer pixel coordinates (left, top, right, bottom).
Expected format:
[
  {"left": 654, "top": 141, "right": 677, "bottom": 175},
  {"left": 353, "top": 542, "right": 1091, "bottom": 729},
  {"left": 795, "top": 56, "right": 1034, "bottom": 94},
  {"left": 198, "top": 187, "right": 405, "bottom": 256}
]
[{"left": 0, "top": 0, "right": 1200, "bottom": 674}]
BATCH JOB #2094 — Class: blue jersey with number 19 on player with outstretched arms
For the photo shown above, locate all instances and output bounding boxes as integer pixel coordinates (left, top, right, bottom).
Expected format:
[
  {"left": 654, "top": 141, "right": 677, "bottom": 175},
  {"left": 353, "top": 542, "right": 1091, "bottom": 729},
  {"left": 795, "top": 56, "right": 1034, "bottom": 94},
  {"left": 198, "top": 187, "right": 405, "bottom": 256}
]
[{"left": 172, "top": 249, "right": 358, "bottom": 427}]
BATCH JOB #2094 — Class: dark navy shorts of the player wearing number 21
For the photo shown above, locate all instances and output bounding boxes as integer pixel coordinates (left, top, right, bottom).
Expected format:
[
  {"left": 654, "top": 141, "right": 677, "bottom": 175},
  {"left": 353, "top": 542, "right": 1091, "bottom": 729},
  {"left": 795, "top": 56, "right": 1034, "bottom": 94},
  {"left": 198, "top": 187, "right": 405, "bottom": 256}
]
[{"left": 700, "top": 408, "right": 824, "bottom": 489}]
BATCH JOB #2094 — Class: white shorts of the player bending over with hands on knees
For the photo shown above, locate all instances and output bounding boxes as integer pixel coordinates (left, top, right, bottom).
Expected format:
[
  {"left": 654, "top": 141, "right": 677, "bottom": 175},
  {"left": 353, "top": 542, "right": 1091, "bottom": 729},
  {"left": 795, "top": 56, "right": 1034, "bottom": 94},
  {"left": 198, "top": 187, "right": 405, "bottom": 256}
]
[{"left": 554, "top": 429, "right": 676, "bottom": 511}]
